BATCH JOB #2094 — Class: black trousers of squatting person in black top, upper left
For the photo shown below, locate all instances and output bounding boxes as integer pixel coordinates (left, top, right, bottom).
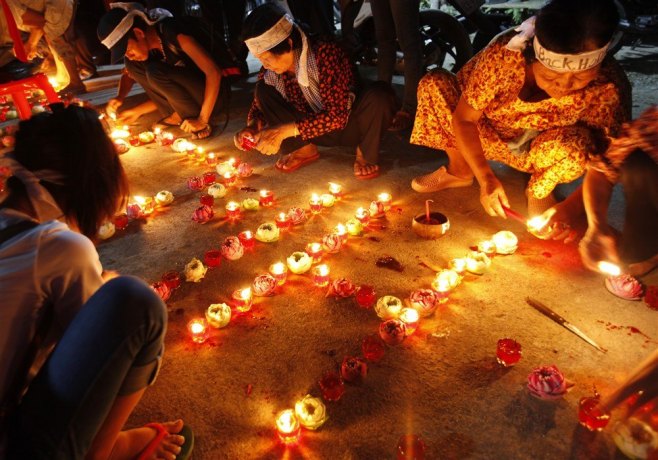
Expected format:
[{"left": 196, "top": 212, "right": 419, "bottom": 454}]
[{"left": 125, "top": 59, "right": 204, "bottom": 119}]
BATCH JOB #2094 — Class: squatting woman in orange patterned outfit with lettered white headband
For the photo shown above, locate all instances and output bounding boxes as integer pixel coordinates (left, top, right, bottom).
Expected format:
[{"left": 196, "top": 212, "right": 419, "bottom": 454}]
[{"left": 411, "top": 0, "right": 630, "bottom": 217}]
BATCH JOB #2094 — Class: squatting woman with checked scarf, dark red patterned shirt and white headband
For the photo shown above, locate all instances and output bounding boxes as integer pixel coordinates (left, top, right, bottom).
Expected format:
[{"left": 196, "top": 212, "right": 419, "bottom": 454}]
[{"left": 235, "top": 3, "right": 395, "bottom": 179}]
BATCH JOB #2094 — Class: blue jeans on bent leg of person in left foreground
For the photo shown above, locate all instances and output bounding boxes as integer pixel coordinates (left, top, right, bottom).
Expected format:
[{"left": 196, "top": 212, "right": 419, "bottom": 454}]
[{"left": 8, "top": 277, "right": 167, "bottom": 460}]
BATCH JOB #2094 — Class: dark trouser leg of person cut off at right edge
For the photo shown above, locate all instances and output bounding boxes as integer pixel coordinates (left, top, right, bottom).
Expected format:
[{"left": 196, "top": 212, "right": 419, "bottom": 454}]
[{"left": 620, "top": 150, "right": 658, "bottom": 263}]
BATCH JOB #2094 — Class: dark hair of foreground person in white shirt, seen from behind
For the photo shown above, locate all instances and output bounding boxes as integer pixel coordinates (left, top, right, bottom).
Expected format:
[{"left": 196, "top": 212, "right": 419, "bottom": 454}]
[{"left": 8, "top": 104, "right": 128, "bottom": 238}]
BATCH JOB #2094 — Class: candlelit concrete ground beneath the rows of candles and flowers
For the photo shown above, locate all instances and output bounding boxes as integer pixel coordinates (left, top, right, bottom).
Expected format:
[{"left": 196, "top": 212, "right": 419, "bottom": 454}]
[{"left": 92, "top": 44, "right": 658, "bottom": 460}]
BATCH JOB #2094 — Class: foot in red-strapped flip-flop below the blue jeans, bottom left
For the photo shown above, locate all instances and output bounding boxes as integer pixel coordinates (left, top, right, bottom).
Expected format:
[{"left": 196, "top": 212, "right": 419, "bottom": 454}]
[{"left": 110, "top": 419, "right": 185, "bottom": 460}]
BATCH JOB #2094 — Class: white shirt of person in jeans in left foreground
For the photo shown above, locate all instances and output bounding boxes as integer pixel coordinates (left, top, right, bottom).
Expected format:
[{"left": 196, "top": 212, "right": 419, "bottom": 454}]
[{"left": 0, "top": 209, "right": 103, "bottom": 406}]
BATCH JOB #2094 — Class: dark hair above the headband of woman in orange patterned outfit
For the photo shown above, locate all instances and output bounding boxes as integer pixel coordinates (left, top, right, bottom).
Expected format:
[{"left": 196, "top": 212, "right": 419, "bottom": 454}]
[{"left": 535, "top": 0, "right": 619, "bottom": 54}]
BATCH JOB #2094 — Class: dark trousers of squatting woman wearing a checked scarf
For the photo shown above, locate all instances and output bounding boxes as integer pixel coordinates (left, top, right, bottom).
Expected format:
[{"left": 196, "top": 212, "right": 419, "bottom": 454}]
[{"left": 256, "top": 80, "right": 395, "bottom": 164}]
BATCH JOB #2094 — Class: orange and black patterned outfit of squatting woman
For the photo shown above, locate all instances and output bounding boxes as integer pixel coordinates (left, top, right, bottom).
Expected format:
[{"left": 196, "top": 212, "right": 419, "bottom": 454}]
[{"left": 411, "top": 33, "right": 630, "bottom": 198}]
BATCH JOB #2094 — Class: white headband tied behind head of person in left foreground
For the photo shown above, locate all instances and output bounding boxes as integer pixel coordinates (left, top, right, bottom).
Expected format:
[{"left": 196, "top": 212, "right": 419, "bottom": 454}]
[{"left": 0, "top": 155, "right": 64, "bottom": 222}]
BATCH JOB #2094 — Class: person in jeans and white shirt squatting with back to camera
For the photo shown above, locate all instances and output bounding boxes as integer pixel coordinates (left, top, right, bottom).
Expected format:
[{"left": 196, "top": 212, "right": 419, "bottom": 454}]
[{"left": 0, "top": 104, "right": 192, "bottom": 460}]
